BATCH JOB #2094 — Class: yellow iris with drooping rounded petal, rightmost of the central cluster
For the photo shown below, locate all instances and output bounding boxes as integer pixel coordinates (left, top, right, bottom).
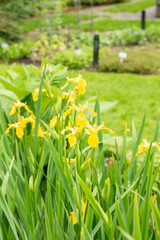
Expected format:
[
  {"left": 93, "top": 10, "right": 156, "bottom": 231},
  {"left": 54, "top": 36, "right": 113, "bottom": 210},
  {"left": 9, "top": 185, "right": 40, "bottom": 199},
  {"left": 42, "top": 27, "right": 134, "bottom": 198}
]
[{"left": 86, "top": 123, "right": 113, "bottom": 148}]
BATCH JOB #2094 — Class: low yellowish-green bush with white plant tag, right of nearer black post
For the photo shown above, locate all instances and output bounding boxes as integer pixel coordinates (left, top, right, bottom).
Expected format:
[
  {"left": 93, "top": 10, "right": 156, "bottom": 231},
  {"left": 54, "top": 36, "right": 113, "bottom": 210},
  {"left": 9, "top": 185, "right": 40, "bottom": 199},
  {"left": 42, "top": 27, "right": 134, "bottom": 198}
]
[{"left": 99, "top": 47, "right": 160, "bottom": 74}]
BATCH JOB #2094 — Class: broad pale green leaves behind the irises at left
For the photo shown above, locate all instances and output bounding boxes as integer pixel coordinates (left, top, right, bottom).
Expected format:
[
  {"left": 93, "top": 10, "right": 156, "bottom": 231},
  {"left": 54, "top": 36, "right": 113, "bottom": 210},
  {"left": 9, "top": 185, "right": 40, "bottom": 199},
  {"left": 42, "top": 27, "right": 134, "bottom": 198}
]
[{"left": 0, "top": 64, "right": 67, "bottom": 110}]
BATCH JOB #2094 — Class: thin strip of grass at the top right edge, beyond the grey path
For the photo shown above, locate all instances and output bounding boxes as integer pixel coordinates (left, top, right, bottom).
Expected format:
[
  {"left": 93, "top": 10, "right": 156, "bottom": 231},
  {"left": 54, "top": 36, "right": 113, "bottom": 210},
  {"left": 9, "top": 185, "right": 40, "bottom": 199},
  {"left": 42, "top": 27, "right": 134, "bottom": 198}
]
[{"left": 104, "top": 0, "right": 156, "bottom": 13}]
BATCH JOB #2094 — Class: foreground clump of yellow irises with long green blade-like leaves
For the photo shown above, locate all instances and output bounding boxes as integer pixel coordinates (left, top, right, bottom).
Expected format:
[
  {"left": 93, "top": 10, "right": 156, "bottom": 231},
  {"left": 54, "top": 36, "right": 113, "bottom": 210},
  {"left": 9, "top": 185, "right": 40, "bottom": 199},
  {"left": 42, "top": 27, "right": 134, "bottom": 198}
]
[{"left": 0, "top": 64, "right": 160, "bottom": 239}]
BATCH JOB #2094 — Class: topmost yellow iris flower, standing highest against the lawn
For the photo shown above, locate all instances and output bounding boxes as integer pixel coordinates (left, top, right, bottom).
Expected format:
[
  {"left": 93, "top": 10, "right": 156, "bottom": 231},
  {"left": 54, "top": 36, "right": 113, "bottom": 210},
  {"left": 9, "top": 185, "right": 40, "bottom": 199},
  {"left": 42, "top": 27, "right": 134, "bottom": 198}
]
[{"left": 61, "top": 74, "right": 86, "bottom": 95}]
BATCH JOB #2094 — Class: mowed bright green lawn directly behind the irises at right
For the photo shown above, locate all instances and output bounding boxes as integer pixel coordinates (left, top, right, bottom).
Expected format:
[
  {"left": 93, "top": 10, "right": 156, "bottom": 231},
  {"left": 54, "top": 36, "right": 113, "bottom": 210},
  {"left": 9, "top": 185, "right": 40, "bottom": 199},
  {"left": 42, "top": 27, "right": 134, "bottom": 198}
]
[{"left": 69, "top": 71, "right": 160, "bottom": 140}]
